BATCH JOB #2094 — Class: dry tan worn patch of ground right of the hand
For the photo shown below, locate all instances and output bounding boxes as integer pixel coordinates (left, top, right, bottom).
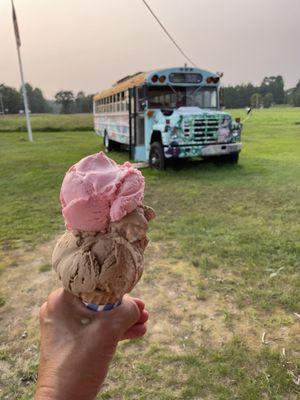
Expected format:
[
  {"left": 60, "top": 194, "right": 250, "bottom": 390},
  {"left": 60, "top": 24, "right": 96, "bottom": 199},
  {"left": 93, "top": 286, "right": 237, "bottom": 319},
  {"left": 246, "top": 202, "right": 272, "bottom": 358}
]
[{"left": 135, "top": 244, "right": 300, "bottom": 353}]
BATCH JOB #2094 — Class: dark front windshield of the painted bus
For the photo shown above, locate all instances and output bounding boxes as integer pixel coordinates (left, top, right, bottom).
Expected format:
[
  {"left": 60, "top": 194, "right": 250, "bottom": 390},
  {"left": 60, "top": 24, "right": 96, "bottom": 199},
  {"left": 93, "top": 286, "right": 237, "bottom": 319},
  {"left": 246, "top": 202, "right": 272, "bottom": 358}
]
[{"left": 147, "top": 86, "right": 218, "bottom": 108}]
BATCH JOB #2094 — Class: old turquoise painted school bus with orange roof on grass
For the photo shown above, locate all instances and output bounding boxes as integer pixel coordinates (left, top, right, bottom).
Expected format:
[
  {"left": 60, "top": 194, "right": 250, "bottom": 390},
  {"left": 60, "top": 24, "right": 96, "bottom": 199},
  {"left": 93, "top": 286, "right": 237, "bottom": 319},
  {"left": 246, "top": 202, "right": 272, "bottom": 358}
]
[{"left": 93, "top": 67, "right": 242, "bottom": 169}]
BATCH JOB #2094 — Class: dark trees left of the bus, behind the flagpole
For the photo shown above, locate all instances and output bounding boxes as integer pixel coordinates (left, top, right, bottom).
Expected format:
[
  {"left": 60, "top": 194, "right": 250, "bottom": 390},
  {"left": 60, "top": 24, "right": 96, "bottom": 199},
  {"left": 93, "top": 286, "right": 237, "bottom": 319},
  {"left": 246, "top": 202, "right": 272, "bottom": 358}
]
[{"left": 0, "top": 83, "right": 94, "bottom": 114}]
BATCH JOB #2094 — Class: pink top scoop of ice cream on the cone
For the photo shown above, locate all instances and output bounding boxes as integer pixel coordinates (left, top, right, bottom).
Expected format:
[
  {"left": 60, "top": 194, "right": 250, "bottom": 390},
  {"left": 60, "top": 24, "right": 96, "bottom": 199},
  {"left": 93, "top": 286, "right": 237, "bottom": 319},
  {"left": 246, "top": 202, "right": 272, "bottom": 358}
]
[{"left": 60, "top": 151, "right": 145, "bottom": 232}]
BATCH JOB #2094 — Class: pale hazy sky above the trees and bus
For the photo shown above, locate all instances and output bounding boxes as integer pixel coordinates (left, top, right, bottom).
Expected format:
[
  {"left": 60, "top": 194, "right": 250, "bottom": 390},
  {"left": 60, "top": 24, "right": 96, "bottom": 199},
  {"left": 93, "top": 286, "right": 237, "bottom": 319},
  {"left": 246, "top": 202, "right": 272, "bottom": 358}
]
[{"left": 0, "top": 0, "right": 300, "bottom": 98}]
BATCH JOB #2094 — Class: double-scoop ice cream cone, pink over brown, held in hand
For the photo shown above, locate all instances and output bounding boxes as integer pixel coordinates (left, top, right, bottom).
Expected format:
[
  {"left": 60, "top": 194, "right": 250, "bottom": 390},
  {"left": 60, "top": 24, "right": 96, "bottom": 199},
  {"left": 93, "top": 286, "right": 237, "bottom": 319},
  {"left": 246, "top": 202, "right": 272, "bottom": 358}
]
[{"left": 52, "top": 153, "right": 155, "bottom": 310}]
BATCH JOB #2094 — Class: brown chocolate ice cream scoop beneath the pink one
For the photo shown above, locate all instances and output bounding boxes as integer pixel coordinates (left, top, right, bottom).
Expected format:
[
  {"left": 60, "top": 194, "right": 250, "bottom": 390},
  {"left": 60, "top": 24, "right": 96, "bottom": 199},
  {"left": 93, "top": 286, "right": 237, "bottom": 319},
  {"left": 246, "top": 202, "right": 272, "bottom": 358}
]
[{"left": 52, "top": 205, "right": 155, "bottom": 304}]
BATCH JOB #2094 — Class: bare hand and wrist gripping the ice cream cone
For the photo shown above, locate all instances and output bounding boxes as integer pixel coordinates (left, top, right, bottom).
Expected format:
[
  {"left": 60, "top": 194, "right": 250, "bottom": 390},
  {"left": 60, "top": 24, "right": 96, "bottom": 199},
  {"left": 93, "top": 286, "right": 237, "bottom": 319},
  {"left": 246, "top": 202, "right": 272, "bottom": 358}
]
[{"left": 35, "top": 289, "right": 148, "bottom": 400}]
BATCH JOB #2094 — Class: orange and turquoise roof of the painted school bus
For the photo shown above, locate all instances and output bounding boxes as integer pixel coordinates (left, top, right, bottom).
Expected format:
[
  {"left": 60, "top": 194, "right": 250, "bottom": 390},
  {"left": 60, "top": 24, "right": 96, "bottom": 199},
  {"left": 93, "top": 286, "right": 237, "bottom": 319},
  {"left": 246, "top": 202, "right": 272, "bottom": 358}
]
[{"left": 94, "top": 67, "right": 220, "bottom": 101}]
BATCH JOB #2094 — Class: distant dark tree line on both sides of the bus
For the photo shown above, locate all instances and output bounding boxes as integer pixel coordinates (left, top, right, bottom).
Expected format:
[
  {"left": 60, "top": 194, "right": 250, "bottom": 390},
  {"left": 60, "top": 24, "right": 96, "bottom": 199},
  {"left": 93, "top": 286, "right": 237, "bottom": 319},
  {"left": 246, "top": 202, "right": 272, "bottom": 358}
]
[{"left": 0, "top": 75, "right": 300, "bottom": 114}]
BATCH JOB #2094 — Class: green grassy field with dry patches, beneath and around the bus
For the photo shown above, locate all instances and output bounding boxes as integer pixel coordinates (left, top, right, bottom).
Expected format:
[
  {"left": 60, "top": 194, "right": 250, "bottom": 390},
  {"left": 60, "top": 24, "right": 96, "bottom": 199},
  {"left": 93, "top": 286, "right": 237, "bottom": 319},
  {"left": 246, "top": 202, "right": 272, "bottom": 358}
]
[{"left": 0, "top": 108, "right": 300, "bottom": 400}]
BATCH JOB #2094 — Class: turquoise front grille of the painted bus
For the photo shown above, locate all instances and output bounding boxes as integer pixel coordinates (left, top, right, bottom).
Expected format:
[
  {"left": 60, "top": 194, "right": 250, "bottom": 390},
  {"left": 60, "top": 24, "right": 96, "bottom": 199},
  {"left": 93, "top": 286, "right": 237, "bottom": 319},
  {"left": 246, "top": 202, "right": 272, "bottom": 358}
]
[{"left": 183, "top": 117, "right": 219, "bottom": 144}]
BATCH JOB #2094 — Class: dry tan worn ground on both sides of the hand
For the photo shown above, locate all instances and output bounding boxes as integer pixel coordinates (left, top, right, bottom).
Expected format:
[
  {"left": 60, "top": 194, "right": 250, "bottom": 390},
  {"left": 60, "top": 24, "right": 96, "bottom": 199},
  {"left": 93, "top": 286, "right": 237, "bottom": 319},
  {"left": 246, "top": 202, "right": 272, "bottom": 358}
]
[{"left": 0, "top": 240, "right": 300, "bottom": 396}]
